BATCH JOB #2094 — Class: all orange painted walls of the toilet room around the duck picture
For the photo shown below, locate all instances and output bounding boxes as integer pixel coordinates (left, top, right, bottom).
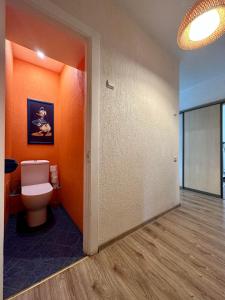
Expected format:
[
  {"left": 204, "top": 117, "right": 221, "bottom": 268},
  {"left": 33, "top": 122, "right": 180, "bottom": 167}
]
[{"left": 6, "top": 49, "right": 84, "bottom": 231}]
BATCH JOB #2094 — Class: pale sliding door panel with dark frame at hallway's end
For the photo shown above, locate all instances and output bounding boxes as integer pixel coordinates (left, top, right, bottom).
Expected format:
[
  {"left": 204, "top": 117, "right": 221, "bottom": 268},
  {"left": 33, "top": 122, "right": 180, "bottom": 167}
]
[{"left": 182, "top": 103, "right": 222, "bottom": 198}]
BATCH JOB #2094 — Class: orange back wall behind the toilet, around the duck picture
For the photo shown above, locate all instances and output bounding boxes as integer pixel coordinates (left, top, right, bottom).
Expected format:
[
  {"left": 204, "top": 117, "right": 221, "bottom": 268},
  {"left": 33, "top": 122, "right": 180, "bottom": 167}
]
[{"left": 11, "top": 59, "right": 59, "bottom": 180}]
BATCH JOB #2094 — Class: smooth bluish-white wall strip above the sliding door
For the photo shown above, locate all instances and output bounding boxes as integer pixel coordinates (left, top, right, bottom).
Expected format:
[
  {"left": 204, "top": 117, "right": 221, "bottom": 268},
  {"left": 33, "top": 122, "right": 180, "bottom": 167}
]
[{"left": 180, "top": 73, "right": 225, "bottom": 110}]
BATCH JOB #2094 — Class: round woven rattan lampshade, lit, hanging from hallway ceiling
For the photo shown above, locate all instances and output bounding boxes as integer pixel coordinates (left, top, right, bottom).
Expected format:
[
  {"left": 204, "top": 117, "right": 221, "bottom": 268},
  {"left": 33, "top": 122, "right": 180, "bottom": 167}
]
[{"left": 177, "top": 0, "right": 225, "bottom": 50}]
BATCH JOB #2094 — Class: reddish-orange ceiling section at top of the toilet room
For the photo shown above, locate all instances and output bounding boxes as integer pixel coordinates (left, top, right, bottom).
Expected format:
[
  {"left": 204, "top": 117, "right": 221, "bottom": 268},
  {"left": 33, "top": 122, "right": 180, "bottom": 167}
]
[{"left": 6, "top": 0, "right": 86, "bottom": 69}]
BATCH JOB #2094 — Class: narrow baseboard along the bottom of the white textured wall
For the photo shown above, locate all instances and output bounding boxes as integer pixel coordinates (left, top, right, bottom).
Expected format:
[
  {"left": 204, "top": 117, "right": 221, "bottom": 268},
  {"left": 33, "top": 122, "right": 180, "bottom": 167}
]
[{"left": 98, "top": 204, "right": 181, "bottom": 252}]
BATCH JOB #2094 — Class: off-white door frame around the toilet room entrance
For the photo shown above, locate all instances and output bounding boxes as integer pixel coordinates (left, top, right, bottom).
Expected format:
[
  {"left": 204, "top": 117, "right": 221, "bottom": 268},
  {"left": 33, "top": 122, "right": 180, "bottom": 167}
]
[{"left": 0, "top": 0, "right": 100, "bottom": 255}]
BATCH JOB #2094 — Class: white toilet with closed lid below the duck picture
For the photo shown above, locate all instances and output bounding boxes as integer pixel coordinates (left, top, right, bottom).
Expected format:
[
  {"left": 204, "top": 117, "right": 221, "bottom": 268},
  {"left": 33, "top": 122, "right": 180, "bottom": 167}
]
[{"left": 21, "top": 160, "right": 53, "bottom": 227}]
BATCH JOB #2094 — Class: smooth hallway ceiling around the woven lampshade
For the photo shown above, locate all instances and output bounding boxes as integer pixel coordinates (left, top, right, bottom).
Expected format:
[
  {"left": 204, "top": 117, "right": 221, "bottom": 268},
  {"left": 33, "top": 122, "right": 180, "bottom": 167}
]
[{"left": 116, "top": 0, "right": 225, "bottom": 90}]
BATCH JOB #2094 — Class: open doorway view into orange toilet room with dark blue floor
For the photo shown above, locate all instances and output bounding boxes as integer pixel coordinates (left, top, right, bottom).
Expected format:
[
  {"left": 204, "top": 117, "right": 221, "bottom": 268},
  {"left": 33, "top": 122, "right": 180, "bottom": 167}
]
[{"left": 4, "top": 38, "right": 85, "bottom": 298}]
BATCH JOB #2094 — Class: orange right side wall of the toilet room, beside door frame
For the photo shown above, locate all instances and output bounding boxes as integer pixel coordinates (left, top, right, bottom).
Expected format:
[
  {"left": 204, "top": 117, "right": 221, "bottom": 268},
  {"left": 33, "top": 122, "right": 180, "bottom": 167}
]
[{"left": 59, "top": 66, "right": 84, "bottom": 231}]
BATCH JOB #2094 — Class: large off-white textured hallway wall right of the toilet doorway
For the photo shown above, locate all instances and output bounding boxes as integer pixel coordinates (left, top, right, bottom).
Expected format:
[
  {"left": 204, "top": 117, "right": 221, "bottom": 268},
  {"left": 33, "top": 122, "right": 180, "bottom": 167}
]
[{"left": 52, "top": 0, "right": 179, "bottom": 244}]
